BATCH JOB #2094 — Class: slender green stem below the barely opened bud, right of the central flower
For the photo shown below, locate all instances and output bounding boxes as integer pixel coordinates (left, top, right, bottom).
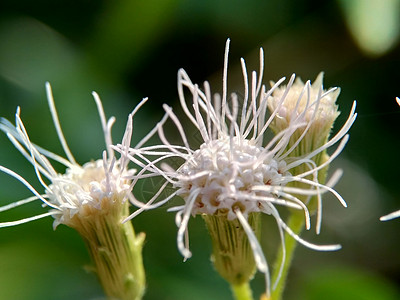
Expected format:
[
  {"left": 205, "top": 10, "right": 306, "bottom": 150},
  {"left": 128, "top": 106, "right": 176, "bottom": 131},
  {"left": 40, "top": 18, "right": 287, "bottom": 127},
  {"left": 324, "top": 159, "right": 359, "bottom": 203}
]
[{"left": 270, "top": 212, "right": 304, "bottom": 300}]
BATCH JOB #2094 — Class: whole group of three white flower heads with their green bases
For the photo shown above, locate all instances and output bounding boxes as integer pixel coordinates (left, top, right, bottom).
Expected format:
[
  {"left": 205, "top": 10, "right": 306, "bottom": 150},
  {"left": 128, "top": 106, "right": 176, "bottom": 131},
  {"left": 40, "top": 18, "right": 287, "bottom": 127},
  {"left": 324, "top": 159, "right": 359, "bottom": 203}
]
[{"left": 0, "top": 40, "right": 357, "bottom": 299}]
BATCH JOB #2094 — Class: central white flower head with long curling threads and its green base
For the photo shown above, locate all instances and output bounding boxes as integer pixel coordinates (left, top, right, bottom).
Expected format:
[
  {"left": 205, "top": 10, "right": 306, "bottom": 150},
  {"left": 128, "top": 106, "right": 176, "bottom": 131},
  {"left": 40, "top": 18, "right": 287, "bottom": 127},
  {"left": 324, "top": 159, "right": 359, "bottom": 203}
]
[{"left": 116, "top": 40, "right": 355, "bottom": 296}]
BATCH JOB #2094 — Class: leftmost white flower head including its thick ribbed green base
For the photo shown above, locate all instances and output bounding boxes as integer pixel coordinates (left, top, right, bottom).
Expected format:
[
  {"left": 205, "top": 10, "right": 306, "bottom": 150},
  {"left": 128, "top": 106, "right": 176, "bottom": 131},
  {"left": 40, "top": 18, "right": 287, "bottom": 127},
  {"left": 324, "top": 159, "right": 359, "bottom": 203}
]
[{"left": 0, "top": 83, "right": 147, "bottom": 299}]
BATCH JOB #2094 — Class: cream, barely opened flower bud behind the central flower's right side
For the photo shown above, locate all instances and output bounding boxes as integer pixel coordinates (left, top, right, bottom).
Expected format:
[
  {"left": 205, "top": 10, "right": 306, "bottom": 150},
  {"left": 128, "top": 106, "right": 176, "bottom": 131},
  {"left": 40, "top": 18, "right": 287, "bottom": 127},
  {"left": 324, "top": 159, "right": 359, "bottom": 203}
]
[{"left": 268, "top": 72, "right": 355, "bottom": 234}]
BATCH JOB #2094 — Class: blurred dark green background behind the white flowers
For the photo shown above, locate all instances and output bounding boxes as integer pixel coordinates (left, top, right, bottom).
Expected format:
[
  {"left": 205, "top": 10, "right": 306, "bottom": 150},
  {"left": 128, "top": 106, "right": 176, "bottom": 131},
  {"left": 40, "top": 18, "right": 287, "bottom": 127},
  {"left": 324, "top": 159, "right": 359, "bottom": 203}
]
[{"left": 0, "top": 0, "right": 400, "bottom": 300}]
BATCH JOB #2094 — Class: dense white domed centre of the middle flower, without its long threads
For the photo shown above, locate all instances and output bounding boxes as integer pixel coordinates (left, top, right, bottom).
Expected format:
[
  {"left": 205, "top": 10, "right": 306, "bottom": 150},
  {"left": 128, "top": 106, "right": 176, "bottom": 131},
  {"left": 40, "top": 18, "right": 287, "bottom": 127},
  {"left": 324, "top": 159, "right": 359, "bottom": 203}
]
[{"left": 179, "top": 137, "right": 286, "bottom": 219}]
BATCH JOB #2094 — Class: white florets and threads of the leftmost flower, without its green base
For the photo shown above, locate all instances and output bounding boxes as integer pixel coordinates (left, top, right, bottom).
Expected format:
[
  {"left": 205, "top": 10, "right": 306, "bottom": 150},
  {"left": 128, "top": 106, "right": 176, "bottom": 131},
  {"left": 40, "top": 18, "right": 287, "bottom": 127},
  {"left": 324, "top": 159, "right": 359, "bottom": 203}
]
[{"left": 0, "top": 83, "right": 147, "bottom": 229}]
